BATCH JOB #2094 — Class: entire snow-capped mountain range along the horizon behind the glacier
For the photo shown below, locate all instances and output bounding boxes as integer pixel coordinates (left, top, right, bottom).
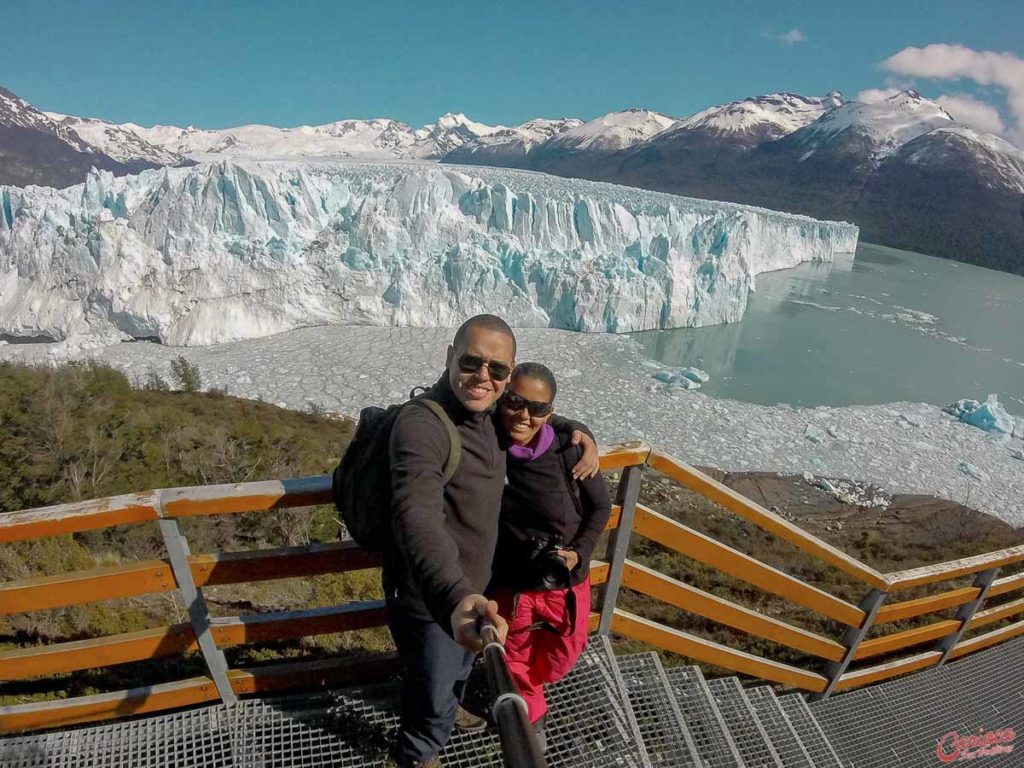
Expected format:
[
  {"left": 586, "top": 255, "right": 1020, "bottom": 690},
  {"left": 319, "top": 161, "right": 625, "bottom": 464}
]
[{"left": 0, "top": 88, "right": 1024, "bottom": 273}]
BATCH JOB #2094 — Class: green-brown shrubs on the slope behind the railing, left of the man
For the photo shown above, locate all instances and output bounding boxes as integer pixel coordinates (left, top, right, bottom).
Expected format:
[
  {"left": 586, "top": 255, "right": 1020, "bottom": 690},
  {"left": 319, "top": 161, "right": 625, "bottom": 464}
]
[{"left": 0, "top": 358, "right": 364, "bottom": 703}]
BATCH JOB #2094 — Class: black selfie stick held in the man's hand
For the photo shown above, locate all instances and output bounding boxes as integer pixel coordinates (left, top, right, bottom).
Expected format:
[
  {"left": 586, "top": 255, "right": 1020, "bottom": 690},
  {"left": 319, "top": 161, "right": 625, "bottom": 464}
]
[{"left": 480, "top": 622, "right": 548, "bottom": 768}]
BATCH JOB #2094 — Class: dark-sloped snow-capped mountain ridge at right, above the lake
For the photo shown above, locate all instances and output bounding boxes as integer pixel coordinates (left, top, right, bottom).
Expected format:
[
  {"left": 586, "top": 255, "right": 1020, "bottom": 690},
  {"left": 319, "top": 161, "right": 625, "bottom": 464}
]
[{"left": 552, "top": 91, "right": 1024, "bottom": 272}]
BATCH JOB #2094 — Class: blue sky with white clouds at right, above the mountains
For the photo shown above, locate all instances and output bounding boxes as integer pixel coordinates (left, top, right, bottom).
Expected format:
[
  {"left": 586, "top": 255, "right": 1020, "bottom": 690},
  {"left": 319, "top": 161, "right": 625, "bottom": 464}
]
[{"left": 0, "top": 0, "right": 1024, "bottom": 145}]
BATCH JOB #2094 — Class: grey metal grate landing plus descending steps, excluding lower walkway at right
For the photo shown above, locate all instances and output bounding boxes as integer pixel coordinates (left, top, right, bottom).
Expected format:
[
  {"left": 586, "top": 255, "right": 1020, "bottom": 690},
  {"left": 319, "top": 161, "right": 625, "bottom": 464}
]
[{"left": 0, "top": 638, "right": 840, "bottom": 768}]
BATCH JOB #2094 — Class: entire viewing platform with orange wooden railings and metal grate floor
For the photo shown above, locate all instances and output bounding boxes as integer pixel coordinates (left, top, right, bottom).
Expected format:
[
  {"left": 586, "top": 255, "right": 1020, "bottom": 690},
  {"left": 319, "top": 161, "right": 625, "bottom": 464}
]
[{"left": 0, "top": 441, "right": 1024, "bottom": 768}]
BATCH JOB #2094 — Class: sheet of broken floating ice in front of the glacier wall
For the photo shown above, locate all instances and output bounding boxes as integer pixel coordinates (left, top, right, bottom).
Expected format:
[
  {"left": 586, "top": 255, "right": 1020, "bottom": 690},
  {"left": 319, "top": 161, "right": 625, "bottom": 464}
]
[{"left": 0, "top": 327, "right": 1024, "bottom": 524}]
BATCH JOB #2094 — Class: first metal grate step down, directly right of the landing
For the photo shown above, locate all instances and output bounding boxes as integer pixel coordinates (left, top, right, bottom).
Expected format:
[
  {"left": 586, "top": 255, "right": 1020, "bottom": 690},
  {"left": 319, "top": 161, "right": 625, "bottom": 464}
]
[{"left": 616, "top": 652, "right": 703, "bottom": 768}]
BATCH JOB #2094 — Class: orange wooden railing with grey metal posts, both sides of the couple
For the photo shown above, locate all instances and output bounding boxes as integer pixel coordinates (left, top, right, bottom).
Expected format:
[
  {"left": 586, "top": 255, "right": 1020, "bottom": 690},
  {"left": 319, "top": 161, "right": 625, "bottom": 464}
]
[{"left": 0, "top": 442, "right": 1024, "bottom": 732}]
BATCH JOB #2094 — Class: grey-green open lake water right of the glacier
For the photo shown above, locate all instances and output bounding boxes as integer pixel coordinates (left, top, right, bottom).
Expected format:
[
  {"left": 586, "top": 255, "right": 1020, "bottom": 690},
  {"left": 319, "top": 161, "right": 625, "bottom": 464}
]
[{"left": 631, "top": 243, "right": 1024, "bottom": 415}]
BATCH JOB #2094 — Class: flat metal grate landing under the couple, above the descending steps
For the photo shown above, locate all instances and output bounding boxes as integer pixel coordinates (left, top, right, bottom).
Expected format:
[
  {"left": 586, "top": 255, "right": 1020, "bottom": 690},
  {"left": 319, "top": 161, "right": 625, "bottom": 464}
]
[{"left": 0, "top": 638, "right": 650, "bottom": 768}]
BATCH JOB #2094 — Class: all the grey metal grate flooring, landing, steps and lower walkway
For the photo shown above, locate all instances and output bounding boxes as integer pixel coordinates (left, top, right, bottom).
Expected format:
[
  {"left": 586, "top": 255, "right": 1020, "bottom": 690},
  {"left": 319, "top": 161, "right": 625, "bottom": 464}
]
[{"left": 14, "top": 637, "right": 1024, "bottom": 768}]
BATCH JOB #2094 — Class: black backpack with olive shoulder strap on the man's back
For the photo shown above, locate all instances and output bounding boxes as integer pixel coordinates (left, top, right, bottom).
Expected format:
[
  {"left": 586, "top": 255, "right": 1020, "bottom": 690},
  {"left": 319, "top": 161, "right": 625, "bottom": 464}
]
[{"left": 331, "top": 390, "right": 462, "bottom": 550}]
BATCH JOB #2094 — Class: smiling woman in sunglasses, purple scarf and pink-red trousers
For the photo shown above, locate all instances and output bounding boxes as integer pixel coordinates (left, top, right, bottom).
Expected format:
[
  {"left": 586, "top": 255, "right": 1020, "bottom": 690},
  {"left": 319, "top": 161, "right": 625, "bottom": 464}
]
[{"left": 492, "top": 362, "right": 611, "bottom": 744}]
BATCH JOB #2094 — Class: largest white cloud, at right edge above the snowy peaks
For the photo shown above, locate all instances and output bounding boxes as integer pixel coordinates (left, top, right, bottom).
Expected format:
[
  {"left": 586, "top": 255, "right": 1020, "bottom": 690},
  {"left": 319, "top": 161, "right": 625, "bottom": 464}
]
[{"left": 882, "top": 44, "right": 1024, "bottom": 145}]
